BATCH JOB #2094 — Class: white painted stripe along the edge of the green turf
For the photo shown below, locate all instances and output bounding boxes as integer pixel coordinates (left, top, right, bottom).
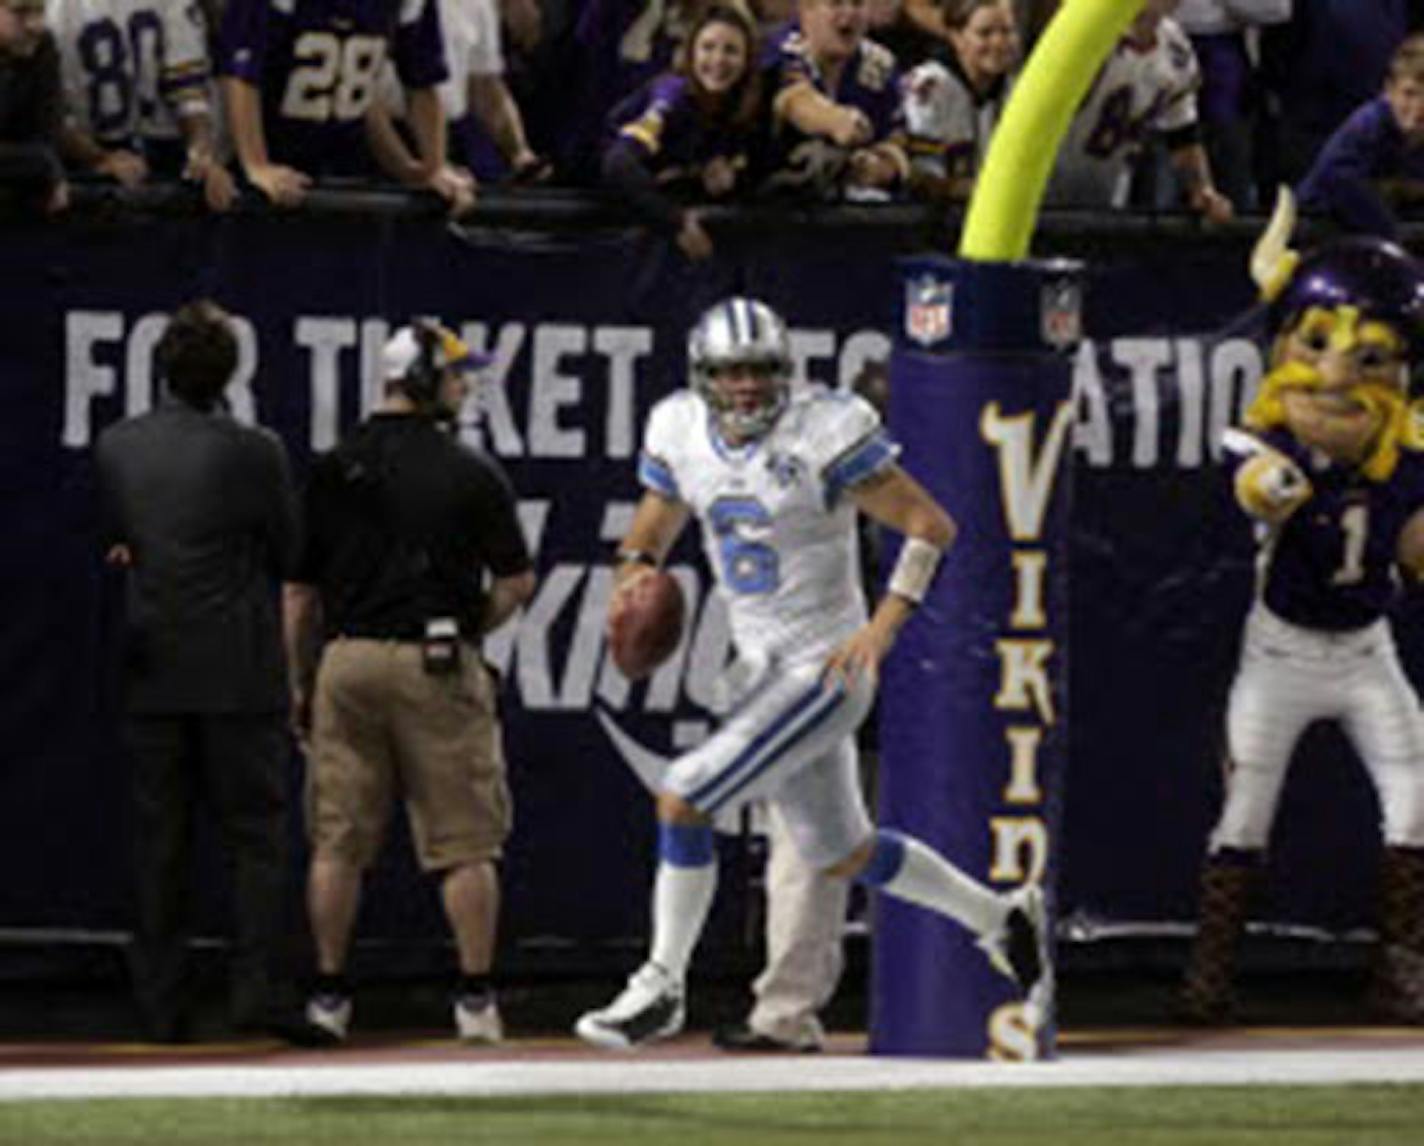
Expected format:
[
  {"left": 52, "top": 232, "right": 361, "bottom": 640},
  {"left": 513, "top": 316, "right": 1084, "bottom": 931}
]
[{"left": 0, "top": 1048, "right": 1424, "bottom": 1102}]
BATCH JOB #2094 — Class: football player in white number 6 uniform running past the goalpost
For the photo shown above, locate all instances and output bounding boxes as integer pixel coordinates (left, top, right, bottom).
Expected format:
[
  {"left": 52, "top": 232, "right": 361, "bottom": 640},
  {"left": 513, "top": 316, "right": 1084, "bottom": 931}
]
[{"left": 575, "top": 298, "right": 1047, "bottom": 1048}]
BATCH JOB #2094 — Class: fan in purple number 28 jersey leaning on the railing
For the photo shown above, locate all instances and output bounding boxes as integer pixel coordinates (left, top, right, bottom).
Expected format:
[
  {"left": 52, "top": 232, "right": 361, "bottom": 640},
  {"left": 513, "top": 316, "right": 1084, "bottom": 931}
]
[{"left": 218, "top": 0, "right": 458, "bottom": 206}]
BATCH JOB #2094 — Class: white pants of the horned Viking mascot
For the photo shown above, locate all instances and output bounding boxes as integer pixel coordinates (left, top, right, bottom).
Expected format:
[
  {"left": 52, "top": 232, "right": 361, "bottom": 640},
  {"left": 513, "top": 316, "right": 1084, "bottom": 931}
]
[{"left": 1210, "top": 602, "right": 1424, "bottom": 851}]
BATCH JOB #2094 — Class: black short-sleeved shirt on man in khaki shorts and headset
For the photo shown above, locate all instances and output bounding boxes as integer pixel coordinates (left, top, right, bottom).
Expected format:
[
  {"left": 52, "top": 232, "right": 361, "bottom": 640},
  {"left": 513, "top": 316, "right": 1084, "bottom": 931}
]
[{"left": 295, "top": 413, "right": 531, "bottom": 639}]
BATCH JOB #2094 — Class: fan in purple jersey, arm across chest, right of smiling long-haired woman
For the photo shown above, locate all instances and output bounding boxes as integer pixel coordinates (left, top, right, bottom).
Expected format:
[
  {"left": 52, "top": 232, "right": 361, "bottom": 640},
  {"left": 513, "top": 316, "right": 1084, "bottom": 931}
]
[{"left": 762, "top": 0, "right": 910, "bottom": 199}]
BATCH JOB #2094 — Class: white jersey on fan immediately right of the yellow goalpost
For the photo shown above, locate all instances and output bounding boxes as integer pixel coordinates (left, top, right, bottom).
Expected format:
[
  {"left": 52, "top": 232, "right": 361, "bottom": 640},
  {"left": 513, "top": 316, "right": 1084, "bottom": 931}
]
[{"left": 1044, "top": 20, "right": 1202, "bottom": 208}]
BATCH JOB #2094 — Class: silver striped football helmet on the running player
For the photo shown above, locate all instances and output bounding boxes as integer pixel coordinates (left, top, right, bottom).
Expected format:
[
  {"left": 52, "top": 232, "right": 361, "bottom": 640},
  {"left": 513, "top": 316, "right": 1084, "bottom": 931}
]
[{"left": 688, "top": 298, "right": 792, "bottom": 441}]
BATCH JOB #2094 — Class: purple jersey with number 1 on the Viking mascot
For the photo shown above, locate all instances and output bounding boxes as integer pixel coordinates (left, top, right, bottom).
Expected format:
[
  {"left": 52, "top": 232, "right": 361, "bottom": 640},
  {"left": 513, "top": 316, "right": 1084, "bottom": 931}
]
[{"left": 1227, "top": 429, "right": 1424, "bottom": 632}]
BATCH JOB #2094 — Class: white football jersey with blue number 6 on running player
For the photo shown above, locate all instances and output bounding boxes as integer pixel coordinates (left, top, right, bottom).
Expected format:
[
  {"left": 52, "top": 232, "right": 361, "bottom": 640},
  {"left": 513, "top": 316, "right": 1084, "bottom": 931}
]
[{"left": 638, "top": 386, "right": 899, "bottom": 662}]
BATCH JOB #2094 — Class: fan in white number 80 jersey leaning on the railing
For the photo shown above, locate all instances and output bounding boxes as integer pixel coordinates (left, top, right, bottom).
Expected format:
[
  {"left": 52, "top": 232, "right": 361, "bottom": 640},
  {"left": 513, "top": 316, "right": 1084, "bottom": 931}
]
[{"left": 47, "top": 0, "right": 234, "bottom": 211}]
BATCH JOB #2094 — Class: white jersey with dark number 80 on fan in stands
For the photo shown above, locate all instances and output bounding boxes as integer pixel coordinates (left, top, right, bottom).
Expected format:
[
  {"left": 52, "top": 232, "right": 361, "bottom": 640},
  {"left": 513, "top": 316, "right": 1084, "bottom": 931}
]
[{"left": 46, "top": 0, "right": 211, "bottom": 147}]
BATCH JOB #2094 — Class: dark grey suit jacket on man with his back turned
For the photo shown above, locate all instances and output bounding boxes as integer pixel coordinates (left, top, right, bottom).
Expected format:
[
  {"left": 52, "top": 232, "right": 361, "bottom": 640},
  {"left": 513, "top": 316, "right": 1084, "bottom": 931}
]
[{"left": 97, "top": 400, "right": 296, "bottom": 713}]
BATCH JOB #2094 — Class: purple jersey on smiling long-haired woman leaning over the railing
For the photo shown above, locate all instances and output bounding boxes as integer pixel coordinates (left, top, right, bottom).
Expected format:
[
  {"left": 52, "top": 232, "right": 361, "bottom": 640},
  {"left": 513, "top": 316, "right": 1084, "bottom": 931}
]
[{"left": 611, "top": 75, "right": 750, "bottom": 188}]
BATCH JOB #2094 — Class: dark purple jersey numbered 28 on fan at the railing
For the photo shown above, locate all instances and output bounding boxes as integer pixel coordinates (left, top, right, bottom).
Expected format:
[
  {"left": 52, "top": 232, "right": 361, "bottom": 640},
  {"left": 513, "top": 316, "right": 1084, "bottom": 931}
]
[{"left": 218, "top": 0, "right": 447, "bottom": 175}]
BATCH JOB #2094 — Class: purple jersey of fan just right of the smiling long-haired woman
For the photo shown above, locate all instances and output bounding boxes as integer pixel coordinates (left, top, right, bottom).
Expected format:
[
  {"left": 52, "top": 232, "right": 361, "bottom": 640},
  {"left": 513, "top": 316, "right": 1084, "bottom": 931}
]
[{"left": 762, "top": 21, "right": 900, "bottom": 198}]
